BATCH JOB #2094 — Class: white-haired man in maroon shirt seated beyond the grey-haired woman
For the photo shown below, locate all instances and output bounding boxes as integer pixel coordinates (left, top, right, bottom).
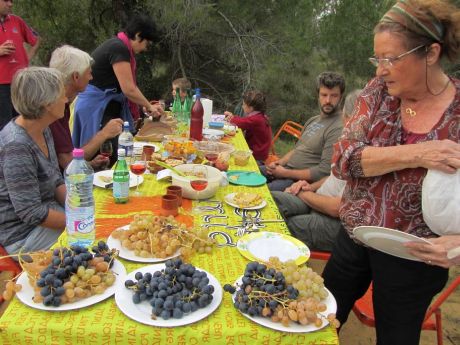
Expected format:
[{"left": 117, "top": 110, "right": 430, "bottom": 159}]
[{"left": 50, "top": 45, "right": 123, "bottom": 170}]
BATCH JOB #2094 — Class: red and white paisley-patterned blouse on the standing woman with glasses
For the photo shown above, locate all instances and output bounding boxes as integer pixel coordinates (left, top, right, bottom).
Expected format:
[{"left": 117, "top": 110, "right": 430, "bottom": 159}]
[{"left": 333, "top": 78, "right": 460, "bottom": 237}]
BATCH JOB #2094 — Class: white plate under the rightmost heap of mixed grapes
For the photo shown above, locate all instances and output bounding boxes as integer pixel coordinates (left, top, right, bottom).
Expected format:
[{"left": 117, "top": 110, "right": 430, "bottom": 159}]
[{"left": 232, "top": 276, "right": 337, "bottom": 333}]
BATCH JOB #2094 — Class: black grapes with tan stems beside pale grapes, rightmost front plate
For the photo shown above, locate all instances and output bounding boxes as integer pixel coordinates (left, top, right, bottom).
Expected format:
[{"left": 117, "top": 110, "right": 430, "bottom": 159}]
[{"left": 224, "top": 262, "right": 299, "bottom": 326}]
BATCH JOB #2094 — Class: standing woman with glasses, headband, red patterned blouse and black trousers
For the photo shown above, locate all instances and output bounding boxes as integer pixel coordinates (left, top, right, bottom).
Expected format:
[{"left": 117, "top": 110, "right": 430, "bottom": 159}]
[{"left": 323, "top": 0, "right": 460, "bottom": 345}]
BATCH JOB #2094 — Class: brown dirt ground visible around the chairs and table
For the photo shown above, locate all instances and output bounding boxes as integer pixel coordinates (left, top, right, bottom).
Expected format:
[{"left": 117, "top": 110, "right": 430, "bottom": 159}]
[{"left": 0, "top": 260, "right": 460, "bottom": 345}]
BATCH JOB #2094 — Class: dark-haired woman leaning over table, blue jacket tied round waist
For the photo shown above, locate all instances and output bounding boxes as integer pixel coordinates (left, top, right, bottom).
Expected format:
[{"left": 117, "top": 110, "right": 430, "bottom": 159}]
[{"left": 72, "top": 15, "right": 163, "bottom": 164}]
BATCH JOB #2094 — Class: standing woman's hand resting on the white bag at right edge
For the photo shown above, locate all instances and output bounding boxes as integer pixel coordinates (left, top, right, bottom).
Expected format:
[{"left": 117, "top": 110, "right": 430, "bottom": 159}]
[{"left": 415, "top": 139, "right": 460, "bottom": 174}]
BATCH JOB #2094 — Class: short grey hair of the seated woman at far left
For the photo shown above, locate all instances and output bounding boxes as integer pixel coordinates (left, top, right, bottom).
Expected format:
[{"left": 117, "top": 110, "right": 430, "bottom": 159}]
[{"left": 11, "top": 67, "right": 64, "bottom": 120}]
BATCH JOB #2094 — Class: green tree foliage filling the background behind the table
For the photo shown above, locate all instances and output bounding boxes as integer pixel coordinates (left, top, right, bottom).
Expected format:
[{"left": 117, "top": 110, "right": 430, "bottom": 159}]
[{"left": 14, "top": 0, "right": 460, "bottom": 130}]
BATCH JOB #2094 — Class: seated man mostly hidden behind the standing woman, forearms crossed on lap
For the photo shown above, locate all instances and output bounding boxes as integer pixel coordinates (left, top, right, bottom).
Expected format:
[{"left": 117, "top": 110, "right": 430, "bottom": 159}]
[{"left": 272, "top": 90, "right": 361, "bottom": 251}]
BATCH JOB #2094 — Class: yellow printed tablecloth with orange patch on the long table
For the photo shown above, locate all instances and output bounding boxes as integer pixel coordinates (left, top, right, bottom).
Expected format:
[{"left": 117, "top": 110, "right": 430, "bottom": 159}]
[{"left": 0, "top": 132, "right": 338, "bottom": 345}]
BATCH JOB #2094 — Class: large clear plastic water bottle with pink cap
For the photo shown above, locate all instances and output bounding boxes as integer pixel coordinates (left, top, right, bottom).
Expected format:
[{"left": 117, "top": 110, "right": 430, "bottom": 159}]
[{"left": 64, "top": 149, "right": 96, "bottom": 247}]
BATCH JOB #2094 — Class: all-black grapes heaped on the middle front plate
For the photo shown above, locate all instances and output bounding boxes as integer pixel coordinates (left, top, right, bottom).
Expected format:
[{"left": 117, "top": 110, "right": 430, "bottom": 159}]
[{"left": 125, "top": 258, "right": 214, "bottom": 320}]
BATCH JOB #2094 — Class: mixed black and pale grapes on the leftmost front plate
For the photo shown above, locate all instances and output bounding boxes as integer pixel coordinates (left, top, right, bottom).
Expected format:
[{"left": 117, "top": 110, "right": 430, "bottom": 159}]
[{"left": 13, "top": 241, "right": 118, "bottom": 307}]
